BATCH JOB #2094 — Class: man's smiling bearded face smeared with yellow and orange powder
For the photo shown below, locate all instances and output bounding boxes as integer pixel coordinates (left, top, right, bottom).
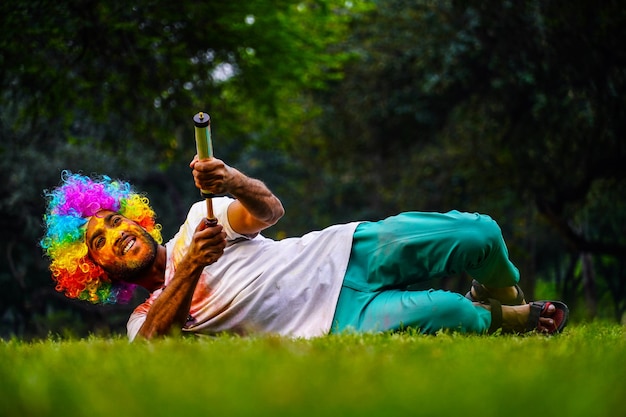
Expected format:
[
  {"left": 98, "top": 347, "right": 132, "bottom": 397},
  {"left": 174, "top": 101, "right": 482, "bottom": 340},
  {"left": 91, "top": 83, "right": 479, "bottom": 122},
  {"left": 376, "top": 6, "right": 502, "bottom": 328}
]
[{"left": 85, "top": 210, "right": 158, "bottom": 283}]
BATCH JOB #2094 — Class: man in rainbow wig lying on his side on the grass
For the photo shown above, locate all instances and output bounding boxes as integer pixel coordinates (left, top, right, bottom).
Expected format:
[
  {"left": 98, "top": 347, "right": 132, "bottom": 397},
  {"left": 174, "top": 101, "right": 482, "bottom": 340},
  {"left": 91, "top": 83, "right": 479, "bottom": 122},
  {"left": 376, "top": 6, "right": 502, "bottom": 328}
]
[{"left": 41, "top": 158, "right": 569, "bottom": 340}]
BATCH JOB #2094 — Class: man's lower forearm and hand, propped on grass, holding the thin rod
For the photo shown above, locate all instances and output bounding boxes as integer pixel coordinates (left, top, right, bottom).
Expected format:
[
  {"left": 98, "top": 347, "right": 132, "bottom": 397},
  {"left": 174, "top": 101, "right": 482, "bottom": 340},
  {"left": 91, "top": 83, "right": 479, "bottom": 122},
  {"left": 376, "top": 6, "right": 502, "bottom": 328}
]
[{"left": 138, "top": 220, "right": 226, "bottom": 339}]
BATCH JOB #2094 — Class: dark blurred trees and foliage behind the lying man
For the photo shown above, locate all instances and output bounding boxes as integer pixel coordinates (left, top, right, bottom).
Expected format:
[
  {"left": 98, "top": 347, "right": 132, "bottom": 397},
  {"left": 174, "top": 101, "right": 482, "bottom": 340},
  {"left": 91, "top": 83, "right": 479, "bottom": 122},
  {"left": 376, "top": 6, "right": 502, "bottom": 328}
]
[{"left": 0, "top": 0, "right": 626, "bottom": 338}]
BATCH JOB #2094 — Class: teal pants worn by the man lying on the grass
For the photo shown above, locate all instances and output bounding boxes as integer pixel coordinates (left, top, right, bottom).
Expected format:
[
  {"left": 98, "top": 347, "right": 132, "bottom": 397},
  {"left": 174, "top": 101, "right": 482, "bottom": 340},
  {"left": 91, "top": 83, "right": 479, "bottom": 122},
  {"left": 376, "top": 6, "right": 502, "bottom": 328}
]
[{"left": 331, "top": 211, "right": 519, "bottom": 334}]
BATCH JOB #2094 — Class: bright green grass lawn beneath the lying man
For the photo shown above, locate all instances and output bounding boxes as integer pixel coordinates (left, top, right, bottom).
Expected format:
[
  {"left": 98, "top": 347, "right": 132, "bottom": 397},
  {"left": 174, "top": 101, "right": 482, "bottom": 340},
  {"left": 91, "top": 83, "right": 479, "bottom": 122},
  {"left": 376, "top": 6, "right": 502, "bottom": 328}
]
[{"left": 0, "top": 323, "right": 626, "bottom": 417}]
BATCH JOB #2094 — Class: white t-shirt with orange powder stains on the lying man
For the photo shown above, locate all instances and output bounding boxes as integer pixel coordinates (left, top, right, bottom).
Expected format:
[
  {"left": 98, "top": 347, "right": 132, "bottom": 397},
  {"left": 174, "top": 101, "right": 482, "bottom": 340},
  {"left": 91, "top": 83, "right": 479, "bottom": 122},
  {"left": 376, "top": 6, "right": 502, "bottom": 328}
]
[{"left": 127, "top": 197, "right": 358, "bottom": 340}]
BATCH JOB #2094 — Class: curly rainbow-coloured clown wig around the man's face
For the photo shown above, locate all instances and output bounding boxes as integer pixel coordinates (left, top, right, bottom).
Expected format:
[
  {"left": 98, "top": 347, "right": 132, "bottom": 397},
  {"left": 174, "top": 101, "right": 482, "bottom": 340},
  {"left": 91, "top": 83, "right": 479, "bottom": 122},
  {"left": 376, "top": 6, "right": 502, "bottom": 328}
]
[{"left": 40, "top": 171, "right": 163, "bottom": 304}]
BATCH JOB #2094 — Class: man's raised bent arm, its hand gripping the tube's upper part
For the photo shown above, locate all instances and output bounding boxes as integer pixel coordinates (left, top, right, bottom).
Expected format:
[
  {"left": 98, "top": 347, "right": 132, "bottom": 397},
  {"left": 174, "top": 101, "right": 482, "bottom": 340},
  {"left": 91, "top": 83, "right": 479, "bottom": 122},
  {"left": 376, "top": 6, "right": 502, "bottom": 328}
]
[{"left": 190, "top": 157, "right": 285, "bottom": 235}]
